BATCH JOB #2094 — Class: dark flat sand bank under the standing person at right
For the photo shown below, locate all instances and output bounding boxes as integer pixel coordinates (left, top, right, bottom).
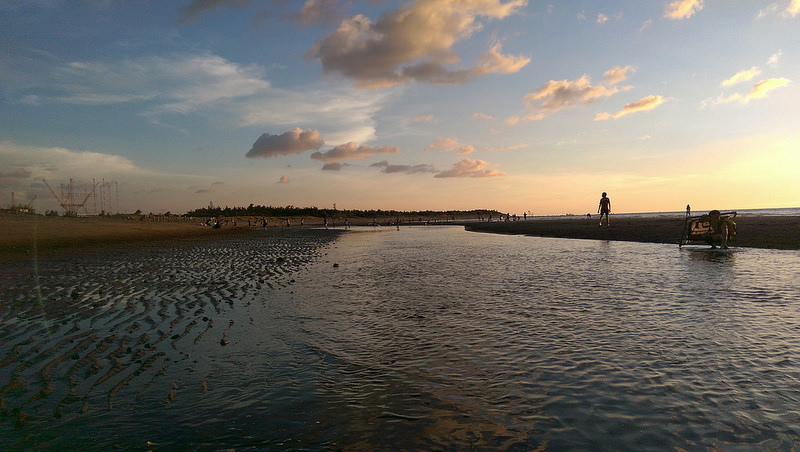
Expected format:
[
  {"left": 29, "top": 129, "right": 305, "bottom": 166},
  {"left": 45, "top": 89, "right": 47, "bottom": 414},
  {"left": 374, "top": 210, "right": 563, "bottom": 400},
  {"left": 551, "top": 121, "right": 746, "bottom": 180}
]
[{"left": 465, "top": 215, "right": 800, "bottom": 250}]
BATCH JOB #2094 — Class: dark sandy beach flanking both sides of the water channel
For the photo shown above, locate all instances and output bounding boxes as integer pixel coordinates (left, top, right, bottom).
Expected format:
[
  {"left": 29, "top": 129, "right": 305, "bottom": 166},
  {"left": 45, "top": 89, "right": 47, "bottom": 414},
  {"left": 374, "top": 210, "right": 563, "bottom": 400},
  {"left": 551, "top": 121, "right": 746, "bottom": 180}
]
[{"left": 0, "top": 215, "right": 800, "bottom": 258}]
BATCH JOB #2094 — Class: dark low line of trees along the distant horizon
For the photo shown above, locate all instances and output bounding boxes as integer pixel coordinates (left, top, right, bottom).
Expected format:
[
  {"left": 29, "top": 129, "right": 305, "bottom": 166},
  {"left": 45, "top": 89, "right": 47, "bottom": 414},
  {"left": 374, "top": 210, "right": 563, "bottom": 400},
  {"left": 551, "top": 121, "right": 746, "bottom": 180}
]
[{"left": 184, "top": 204, "right": 500, "bottom": 218}]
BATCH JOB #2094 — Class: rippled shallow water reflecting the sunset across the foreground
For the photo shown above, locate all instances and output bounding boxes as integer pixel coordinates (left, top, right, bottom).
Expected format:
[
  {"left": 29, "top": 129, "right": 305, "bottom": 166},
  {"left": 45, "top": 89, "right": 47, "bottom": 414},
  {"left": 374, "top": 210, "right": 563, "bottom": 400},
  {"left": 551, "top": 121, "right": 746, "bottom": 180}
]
[{"left": 0, "top": 227, "right": 800, "bottom": 450}]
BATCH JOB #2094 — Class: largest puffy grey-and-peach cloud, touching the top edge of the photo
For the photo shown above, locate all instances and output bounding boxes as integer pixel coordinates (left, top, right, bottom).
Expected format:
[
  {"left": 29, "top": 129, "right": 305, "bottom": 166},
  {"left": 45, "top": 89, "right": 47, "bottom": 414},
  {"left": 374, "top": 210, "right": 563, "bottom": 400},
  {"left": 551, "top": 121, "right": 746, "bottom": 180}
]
[{"left": 306, "top": 0, "right": 529, "bottom": 89}]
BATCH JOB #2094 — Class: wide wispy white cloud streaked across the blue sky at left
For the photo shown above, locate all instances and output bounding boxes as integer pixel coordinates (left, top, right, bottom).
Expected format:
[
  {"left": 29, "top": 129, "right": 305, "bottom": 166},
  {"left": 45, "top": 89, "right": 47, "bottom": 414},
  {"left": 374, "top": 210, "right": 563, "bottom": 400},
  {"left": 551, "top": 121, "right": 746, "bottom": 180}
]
[{"left": 17, "top": 53, "right": 391, "bottom": 143}]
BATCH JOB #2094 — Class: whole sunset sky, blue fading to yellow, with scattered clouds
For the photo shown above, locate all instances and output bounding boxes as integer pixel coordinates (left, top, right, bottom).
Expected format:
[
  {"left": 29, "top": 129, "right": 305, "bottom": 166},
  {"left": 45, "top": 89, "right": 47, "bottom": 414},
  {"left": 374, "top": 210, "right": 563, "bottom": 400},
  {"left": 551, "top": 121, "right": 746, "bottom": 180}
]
[{"left": 0, "top": 0, "right": 800, "bottom": 215}]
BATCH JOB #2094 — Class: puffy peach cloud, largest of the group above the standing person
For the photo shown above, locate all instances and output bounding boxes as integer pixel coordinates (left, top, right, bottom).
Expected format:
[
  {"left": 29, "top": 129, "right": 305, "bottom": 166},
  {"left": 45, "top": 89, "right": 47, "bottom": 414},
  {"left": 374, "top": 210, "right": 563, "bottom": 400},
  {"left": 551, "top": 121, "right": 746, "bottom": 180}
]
[{"left": 523, "top": 74, "right": 619, "bottom": 112}]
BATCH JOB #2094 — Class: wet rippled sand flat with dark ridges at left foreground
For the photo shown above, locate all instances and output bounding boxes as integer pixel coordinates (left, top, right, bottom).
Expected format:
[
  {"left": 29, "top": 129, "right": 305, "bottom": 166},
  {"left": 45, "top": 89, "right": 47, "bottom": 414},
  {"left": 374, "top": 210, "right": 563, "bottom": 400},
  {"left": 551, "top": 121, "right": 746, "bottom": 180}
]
[{"left": 0, "top": 230, "right": 338, "bottom": 448}]
